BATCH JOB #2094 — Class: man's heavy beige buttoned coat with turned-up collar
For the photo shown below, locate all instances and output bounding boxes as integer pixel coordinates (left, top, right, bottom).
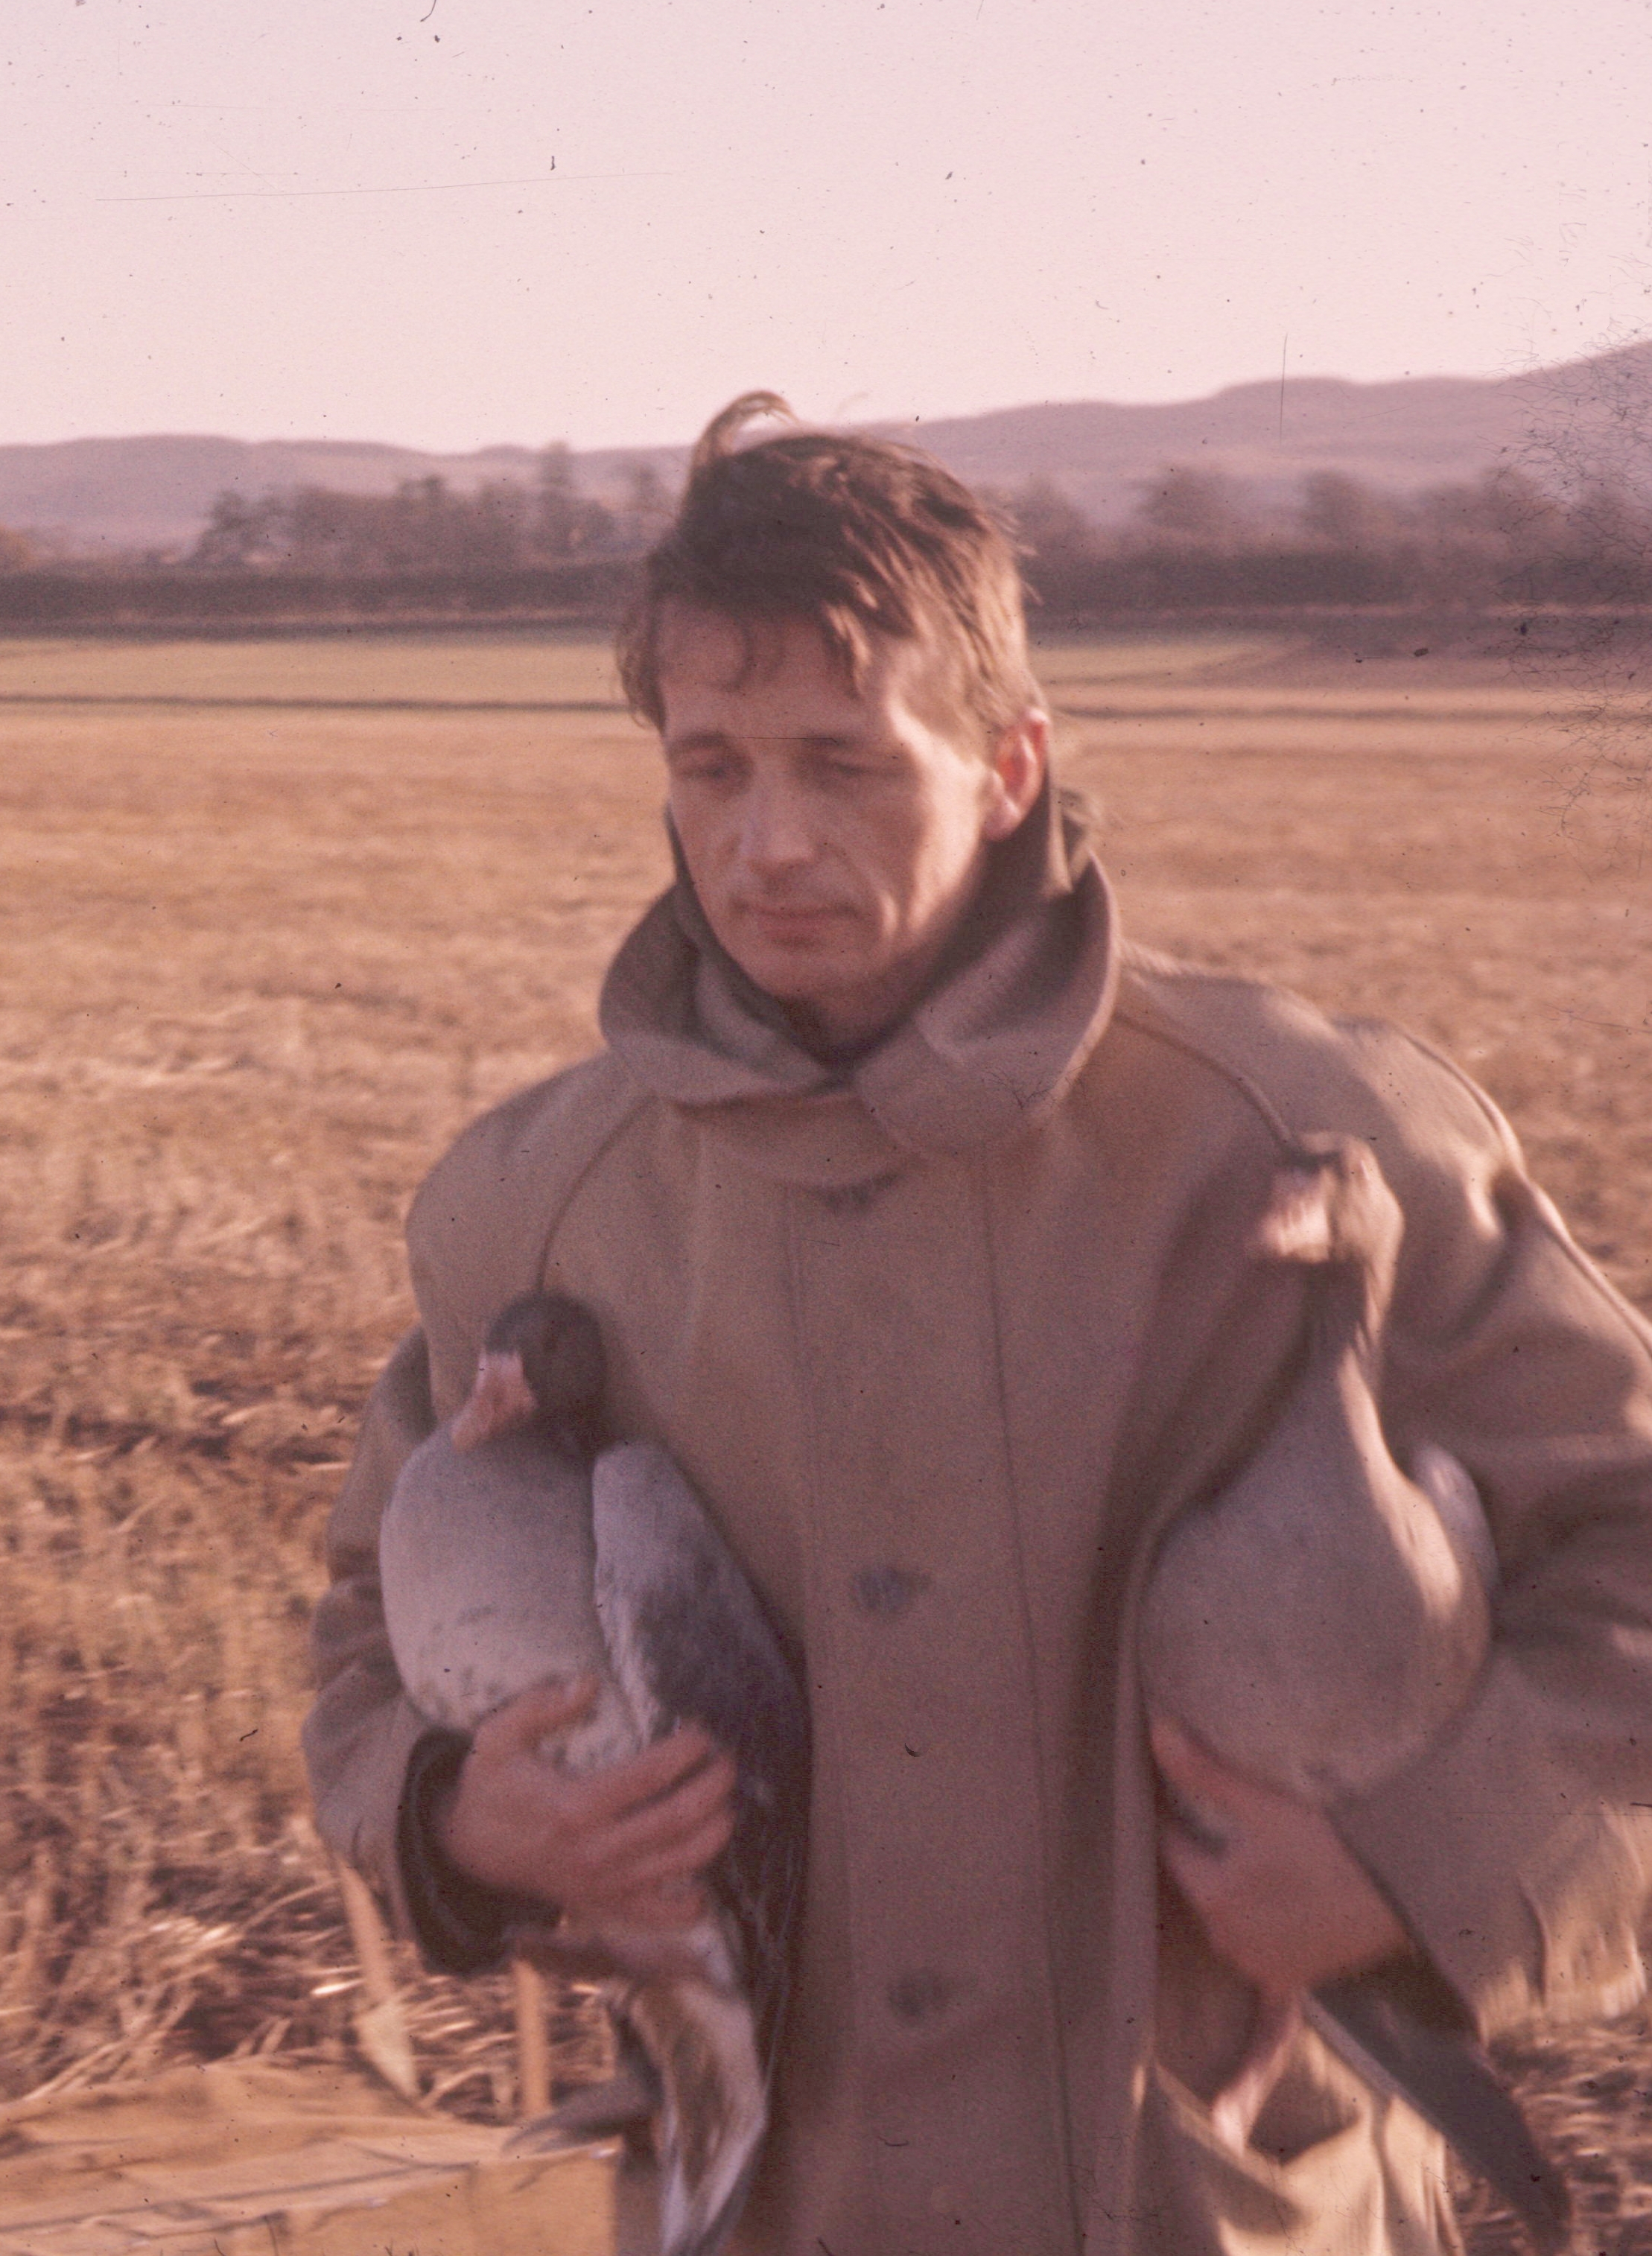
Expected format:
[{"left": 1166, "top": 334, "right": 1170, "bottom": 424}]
[{"left": 309, "top": 798, "right": 1652, "bottom": 2256}]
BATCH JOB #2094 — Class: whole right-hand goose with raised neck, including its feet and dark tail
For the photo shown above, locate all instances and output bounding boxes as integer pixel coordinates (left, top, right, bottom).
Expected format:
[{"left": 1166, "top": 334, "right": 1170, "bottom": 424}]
[{"left": 1140, "top": 1137, "right": 1569, "bottom": 2252}]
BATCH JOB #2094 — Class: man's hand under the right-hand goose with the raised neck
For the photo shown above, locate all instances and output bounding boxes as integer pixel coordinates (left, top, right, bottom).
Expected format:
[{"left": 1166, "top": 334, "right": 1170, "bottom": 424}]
[{"left": 1153, "top": 1719, "right": 1411, "bottom": 1999}]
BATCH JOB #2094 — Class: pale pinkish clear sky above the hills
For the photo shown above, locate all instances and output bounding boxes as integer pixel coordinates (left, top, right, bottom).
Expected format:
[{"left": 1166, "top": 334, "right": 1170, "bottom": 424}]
[{"left": 0, "top": 0, "right": 1652, "bottom": 449}]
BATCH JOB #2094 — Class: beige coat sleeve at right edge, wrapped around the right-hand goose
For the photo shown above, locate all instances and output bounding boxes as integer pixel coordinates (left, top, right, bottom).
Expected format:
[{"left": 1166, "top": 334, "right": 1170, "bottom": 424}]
[{"left": 1332, "top": 1044, "right": 1652, "bottom": 2037}]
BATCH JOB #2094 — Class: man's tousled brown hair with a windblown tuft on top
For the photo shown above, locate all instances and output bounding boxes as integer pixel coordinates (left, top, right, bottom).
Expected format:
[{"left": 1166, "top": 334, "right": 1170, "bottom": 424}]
[{"left": 618, "top": 393, "right": 1041, "bottom": 737}]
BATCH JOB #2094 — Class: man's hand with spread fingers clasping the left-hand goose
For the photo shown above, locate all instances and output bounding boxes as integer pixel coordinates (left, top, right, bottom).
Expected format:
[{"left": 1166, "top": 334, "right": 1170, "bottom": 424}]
[{"left": 438, "top": 1677, "right": 734, "bottom": 1927}]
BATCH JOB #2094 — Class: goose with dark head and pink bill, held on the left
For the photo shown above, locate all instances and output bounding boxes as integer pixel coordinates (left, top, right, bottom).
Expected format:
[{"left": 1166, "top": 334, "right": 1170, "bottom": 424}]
[{"left": 379, "top": 1293, "right": 808, "bottom": 2256}]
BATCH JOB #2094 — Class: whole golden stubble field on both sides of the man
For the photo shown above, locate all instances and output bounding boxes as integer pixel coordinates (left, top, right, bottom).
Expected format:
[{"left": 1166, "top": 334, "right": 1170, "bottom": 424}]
[{"left": 0, "top": 636, "right": 1652, "bottom": 2256}]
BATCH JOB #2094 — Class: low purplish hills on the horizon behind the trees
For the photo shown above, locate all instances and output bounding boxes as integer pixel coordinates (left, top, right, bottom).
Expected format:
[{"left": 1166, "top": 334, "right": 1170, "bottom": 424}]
[{"left": 0, "top": 343, "right": 1652, "bottom": 550}]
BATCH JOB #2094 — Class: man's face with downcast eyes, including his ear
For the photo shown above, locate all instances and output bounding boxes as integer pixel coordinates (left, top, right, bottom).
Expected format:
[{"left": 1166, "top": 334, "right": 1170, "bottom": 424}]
[{"left": 659, "top": 605, "right": 1045, "bottom": 1044}]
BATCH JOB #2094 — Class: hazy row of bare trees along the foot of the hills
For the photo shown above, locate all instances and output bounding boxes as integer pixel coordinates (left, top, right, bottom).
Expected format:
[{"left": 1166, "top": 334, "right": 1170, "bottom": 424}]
[{"left": 0, "top": 447, "right": 1652, "bottom": 618}]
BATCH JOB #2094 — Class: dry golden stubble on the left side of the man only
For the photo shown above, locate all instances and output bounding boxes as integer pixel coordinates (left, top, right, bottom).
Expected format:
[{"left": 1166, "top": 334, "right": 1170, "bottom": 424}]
[{"left": 0, "top": 643, "right": 664, "bottom": 2112}]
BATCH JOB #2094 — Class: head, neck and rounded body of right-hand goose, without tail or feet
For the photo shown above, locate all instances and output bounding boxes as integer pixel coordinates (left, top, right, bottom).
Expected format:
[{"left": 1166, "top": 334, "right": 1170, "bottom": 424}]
[{"left": 1140, "top": 1140, "right": 1496, "bottom": 1805}]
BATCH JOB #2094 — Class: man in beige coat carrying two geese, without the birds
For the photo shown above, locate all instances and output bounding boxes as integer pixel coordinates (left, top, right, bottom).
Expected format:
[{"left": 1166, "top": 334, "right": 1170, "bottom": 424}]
[{"left": 309, "top": 395, "right": 1652, "bottom": 2256}]
